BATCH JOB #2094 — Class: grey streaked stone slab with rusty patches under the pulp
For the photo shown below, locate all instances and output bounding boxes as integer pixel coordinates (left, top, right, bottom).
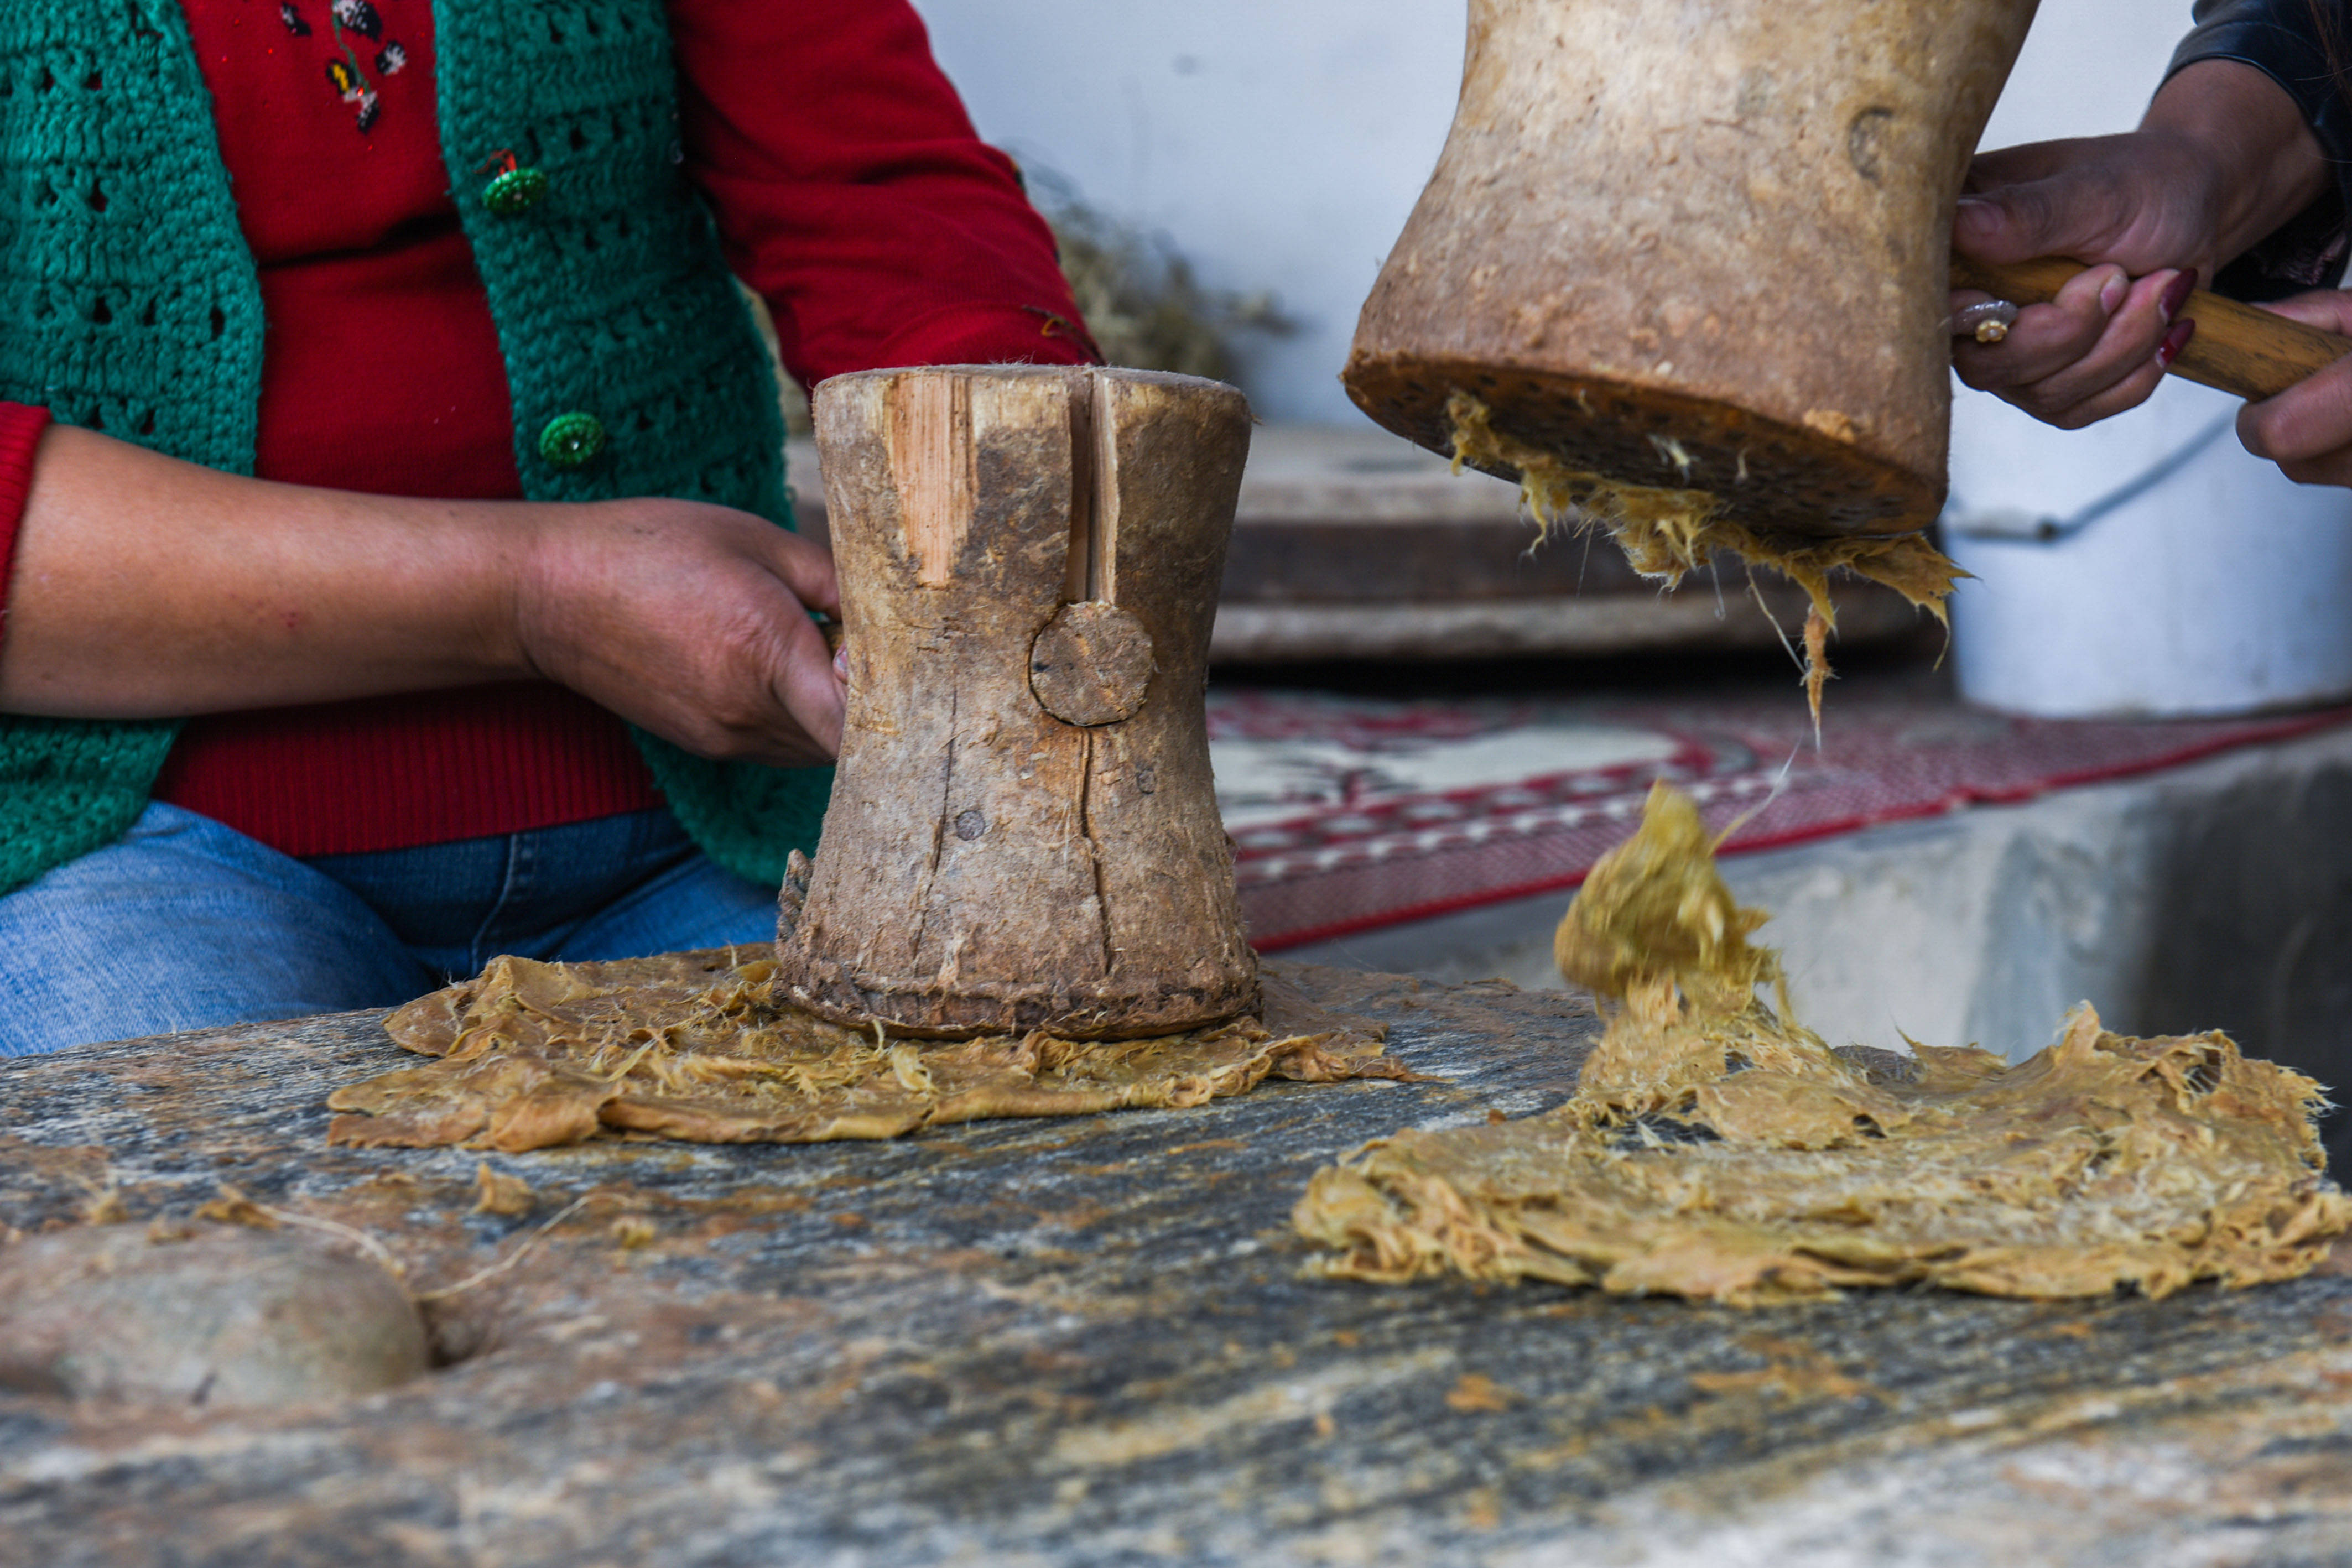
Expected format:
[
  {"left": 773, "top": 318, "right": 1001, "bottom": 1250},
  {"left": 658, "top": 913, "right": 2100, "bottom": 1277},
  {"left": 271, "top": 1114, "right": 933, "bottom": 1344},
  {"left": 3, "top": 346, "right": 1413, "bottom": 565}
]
[{"left": 0, "top": 968, "right": 2352, "bottom": 1568}]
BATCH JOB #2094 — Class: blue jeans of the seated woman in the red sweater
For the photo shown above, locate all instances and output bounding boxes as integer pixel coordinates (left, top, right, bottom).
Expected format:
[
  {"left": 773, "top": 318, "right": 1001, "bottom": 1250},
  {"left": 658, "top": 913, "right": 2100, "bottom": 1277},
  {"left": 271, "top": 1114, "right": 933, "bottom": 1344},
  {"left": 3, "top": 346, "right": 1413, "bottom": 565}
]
[{"left": 0, "top": 801, "right": 776, "bottom": 1055}]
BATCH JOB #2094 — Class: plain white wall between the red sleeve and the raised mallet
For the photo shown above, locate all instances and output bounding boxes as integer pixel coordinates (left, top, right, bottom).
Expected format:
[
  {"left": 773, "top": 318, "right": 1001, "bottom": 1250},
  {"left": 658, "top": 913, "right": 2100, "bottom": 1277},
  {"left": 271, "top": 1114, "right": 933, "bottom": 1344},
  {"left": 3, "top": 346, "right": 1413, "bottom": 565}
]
[{"left": 915, "top": 0, "right": 1463, "bottom": 423}]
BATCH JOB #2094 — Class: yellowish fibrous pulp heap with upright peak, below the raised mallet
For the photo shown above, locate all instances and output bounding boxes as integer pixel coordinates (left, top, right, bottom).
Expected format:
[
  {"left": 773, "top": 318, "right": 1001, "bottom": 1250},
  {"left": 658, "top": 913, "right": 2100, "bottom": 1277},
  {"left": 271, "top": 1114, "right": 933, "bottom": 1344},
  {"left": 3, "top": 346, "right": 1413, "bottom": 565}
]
[{"left": 1296, "top": 785, "right": 2352, "bottom": 1305}]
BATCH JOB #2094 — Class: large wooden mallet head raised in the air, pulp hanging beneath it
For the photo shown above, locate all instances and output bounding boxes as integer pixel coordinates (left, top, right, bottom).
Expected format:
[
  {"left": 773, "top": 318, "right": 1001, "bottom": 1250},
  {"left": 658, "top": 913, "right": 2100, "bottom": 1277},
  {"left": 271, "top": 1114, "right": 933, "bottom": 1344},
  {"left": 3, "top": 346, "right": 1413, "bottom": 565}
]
[{"left": 1345, "top": 0, "right": 2034, "bottom": 534}]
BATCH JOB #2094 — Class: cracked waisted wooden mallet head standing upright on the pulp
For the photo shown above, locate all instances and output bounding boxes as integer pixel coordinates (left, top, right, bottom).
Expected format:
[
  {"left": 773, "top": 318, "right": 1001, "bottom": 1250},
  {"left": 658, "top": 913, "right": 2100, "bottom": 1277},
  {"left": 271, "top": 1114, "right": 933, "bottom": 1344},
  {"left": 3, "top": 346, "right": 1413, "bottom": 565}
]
[{"left": 776, "top": 364, "right": 1258, "bottom": 1039}]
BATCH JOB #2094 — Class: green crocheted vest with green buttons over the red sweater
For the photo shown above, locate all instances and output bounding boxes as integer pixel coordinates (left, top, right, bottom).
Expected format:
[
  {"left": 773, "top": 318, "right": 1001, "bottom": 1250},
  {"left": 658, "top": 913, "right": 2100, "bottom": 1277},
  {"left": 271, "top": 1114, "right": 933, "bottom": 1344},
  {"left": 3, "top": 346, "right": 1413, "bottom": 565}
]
[{"left": 0, "top": 0, "right": 832, "bottom": 893}]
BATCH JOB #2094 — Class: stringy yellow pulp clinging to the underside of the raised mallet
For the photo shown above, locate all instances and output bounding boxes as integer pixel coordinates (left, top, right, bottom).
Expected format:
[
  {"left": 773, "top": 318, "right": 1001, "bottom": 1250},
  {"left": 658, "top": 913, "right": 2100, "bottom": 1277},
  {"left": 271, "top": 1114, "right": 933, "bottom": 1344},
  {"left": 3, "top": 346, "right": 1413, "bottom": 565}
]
[{"left": 1446, "top": 393, "right": 1964, "bottom": 736}]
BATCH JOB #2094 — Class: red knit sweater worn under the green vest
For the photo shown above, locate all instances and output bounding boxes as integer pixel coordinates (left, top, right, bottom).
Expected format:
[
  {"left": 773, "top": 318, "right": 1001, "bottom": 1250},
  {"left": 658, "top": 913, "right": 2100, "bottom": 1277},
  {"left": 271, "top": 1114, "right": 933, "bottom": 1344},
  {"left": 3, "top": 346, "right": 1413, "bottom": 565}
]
[{"left": 0, "top": 0, "right": 1086, "bottom": 856}]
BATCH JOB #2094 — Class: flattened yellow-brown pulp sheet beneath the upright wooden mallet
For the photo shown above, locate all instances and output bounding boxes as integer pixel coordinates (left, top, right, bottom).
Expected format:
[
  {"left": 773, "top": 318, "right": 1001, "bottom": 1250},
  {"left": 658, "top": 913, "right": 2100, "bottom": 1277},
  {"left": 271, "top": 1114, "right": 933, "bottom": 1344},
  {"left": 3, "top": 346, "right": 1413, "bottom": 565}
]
[{"left": 327, "top": 947, "right": 1409, "bottom": 1154}]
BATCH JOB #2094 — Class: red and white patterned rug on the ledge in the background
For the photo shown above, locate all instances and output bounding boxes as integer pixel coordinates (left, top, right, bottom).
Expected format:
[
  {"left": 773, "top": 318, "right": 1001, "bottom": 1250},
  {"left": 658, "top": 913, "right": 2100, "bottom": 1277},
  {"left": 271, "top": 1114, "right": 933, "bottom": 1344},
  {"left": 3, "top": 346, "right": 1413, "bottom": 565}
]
[{"left": 1209, "top": 689, "right": 2352, "bottom": 952}]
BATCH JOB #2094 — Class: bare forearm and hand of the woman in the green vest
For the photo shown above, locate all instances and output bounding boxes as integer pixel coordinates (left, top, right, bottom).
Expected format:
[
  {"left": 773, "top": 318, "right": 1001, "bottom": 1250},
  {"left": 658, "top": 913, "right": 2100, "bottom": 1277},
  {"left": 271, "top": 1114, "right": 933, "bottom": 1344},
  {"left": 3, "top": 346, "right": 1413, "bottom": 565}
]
[{"left": 0, "top": 414, "right": 842, "bottom": 767}]
